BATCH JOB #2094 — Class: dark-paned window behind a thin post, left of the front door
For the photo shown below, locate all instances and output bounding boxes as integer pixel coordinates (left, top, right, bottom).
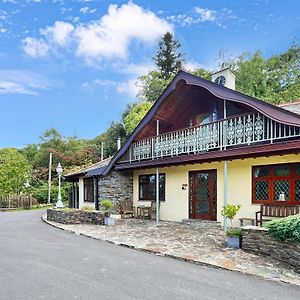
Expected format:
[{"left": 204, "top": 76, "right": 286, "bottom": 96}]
[{"left": 139, "top": 174, "right": 165, "bottom": 201}]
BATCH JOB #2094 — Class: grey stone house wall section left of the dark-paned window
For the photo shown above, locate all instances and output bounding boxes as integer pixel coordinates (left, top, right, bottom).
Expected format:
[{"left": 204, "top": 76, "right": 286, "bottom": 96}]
[{"left": 98, "top": 170, "right": 133, "bottom": 203}]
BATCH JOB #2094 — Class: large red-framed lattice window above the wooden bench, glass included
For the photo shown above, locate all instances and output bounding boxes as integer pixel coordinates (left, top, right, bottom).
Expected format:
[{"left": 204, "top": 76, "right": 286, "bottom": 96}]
[{"left": 252, "top": 164, "right": 300, "bottom": 205}]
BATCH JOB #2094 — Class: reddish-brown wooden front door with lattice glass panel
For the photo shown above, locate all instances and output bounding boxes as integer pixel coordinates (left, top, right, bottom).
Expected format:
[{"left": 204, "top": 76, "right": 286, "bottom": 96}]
[{"left": 189, "top": 170, "right": 217, "bottom": 221}]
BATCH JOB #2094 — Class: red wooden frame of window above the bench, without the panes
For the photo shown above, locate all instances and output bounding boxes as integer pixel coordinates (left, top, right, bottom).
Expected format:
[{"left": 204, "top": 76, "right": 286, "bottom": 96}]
[{"left": 251, "top": 163, "right": 300, "bottom": 206}]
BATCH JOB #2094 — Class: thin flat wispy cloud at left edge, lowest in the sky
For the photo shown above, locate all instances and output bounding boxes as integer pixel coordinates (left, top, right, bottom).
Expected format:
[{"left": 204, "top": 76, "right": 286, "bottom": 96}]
[{"left": 0, "top": 70, "right": 51, "bottom": 96}]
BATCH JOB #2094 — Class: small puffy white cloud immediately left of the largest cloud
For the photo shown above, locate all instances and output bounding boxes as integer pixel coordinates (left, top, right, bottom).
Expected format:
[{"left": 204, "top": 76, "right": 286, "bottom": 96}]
[{"left": 40, "top": 21, "right": 74, "bottom": 46}]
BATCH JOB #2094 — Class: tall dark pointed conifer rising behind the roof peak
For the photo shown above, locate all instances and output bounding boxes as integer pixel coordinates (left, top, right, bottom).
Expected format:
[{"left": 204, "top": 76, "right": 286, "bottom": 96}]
[{"left": 154, "top": 32, "right": 182, "bottom": 80}]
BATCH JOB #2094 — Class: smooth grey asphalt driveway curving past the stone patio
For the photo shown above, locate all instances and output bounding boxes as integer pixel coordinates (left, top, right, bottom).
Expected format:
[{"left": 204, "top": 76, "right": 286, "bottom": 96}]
[{"left": 0, "top": 211, "right": 300, "bottom": 300}]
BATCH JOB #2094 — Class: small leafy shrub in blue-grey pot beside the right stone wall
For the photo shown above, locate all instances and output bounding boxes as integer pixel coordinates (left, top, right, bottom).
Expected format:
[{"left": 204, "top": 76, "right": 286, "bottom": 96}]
[{"left": 221, "top": 204, "right": 241, "bottom": 248}]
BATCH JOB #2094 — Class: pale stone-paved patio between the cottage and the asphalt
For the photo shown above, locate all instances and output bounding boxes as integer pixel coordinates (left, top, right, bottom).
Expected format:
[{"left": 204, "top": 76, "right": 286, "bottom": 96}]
[{"left": 43, "top": 216, "right": 300, "bottom": 286}]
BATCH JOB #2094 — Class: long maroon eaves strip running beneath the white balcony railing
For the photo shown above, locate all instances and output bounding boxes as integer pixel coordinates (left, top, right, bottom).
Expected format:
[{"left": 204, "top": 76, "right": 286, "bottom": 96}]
[{"left": 115, "top": 140, "right": 300, "bottom": 170}]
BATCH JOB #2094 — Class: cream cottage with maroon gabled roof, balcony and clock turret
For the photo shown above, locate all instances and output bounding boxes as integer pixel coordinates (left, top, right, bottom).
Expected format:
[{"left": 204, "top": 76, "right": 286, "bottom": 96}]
[{"left": 65, "top": 68, "right": 300, "bottom": 226}]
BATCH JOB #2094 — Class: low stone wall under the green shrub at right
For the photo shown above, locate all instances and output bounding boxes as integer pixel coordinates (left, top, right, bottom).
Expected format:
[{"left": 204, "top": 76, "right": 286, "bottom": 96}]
[{"left": 242, "top": 226, "right": 300, "bottom": 273}]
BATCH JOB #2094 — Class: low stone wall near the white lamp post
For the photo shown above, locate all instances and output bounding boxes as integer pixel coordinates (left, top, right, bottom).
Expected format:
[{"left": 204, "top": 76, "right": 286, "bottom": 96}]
[{"left": 47, "top": 208, "right": 104, "bottom": 225}]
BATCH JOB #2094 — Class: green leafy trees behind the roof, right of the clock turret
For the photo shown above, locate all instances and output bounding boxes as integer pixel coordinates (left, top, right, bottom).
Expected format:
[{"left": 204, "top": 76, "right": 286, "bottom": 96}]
[{"left": 224, "top": 44, "right": 300, "bottom": 104}]
